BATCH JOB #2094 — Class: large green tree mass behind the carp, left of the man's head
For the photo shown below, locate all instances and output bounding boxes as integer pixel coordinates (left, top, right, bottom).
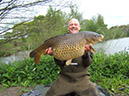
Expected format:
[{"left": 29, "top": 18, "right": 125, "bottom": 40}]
[{"left": 1, "top": 6, "right": 67, "bottom": 54}]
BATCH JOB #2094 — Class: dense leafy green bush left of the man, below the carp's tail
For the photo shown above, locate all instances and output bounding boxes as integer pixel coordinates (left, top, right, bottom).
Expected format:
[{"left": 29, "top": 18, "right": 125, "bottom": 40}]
[{"left": 0, "top": 56, "right": 60, "bottom": 87}]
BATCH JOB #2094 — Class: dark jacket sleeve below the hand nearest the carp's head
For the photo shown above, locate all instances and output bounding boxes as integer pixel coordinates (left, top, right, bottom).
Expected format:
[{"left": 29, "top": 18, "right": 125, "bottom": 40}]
[{"left": 82, "top": 51, "right": 93, "bottom": 67}]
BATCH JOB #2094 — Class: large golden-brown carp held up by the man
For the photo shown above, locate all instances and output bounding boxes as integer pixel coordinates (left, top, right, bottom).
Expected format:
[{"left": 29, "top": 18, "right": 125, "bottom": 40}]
[{"left": 30, "top": 31, "right": 104, "bottom": 65}]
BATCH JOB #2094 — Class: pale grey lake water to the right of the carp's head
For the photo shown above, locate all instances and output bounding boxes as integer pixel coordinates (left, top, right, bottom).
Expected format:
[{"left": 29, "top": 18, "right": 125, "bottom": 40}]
[{"left": 93, "top": 37, "right": 129, "bottom": 55}]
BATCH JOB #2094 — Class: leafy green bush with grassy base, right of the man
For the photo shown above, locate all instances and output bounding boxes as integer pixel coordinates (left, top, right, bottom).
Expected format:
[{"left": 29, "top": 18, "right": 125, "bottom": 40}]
[{"left": 89, "top": 52, "right": 129, "bottom": 96}]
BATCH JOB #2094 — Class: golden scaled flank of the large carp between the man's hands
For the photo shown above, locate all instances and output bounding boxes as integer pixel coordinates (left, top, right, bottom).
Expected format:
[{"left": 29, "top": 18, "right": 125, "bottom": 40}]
[{"left": 52, "top": 38, "right": 86, "bottom": 60}]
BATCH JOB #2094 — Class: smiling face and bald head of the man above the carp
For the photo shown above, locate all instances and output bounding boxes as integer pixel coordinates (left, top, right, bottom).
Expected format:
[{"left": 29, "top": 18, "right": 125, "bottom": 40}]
[{"left": 68, "top": 20, "right": 81, "bottom": 33}]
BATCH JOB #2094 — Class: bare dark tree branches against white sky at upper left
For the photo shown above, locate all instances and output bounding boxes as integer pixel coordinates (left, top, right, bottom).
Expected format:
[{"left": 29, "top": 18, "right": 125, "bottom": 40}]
[{"left": 0, "top": 0, "right": 74, "bottom": 45}]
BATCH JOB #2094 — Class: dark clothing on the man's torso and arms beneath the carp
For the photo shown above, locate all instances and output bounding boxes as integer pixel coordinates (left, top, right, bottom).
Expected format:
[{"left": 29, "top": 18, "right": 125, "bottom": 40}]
[{"left": 54, "top": 51, "right": 93, "bottom": 82}]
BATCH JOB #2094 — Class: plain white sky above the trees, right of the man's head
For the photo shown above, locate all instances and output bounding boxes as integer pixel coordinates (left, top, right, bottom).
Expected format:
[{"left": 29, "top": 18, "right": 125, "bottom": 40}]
[{"left": 79, "top": 0, "right": 129, "bottom": 28}]
